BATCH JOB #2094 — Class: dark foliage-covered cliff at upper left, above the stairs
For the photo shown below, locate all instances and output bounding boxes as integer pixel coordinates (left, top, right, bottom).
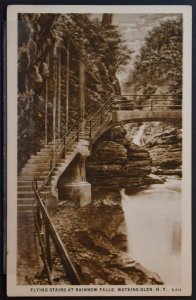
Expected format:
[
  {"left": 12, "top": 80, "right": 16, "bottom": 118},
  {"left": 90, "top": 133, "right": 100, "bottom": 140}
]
[{"left": 18, "top": 14, "right": 130, "bottom": 170}]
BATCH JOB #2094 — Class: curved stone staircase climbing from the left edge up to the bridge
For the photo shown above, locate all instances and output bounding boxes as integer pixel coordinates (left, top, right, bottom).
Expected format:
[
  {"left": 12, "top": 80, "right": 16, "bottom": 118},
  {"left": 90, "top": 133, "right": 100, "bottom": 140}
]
[{"left": 17, "top": 102, "right": 112, "bottom": 218}]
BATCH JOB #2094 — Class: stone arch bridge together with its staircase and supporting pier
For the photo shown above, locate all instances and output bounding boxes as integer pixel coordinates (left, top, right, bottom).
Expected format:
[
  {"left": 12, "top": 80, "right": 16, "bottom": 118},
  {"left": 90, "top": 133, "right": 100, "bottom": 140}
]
[{"left": 18, "top": 95, "right": 182, "bottom": 214}]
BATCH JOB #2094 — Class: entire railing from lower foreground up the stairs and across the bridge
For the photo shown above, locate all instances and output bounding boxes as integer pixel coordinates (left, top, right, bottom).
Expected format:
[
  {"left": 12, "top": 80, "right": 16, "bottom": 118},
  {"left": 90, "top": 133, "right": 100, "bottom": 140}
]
[{"left": 30, "top": 95, "right": 182, "bottom": 284}]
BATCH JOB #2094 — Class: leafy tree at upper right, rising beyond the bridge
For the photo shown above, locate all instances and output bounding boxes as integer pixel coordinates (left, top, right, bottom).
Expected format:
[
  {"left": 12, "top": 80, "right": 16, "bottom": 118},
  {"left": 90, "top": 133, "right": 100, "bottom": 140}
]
[{"left": 126, "top": 18, "right": 183, "bottom": 95}]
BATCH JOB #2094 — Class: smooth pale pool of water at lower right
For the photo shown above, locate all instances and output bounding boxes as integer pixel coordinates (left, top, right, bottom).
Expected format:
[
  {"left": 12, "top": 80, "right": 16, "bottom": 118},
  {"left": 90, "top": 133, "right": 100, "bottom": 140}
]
[{"left": 121, "top": 178, "right": 181, "bottom": 284}]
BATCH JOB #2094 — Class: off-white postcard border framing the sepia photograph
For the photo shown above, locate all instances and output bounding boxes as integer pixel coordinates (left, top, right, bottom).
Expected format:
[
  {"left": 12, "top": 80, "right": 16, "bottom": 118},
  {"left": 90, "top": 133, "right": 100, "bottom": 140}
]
[{"left": 7, "top": 5, "right": 192, "bottom": 296}]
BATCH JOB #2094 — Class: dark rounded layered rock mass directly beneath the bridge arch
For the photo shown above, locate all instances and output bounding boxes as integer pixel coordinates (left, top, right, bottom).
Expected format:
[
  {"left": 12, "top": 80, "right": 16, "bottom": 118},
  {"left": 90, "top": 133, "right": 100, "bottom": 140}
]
[{"left": 87, "top": 126, "right": 151, "bottom": 192}]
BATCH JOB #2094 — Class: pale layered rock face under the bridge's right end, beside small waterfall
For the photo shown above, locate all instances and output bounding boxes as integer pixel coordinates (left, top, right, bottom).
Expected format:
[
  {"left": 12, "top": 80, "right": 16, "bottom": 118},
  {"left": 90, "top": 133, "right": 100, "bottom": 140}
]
[{"left": 125, "top": 122, "right": 182, "bottom": 176}]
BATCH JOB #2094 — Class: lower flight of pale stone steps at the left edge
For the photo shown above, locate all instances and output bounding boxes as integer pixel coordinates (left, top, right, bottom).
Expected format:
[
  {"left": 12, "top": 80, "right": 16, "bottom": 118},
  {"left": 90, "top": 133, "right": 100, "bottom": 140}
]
[{"left": 17, "top": 140, "right": 78, "bottom": 218}]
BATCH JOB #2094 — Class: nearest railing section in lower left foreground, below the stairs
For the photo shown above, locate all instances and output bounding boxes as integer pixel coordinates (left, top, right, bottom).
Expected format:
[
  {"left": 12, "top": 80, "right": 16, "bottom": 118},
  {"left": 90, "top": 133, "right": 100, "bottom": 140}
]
[{"left": 32, "top": 180, "right": 82, "bottom": 285}]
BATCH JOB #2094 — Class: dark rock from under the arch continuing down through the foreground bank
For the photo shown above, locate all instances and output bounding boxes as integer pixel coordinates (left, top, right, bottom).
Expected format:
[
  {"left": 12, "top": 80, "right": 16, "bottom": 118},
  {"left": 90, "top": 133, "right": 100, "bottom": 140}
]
[{"left": 47, "top": 126, "right": 167, "bottom": 285}]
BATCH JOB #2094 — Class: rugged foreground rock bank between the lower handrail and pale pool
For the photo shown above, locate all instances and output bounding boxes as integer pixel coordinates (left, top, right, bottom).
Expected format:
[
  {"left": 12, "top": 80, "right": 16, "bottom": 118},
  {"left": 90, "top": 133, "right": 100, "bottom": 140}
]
[{"left": 52, "top": 192, "right": 163, "bottom": 285}]
